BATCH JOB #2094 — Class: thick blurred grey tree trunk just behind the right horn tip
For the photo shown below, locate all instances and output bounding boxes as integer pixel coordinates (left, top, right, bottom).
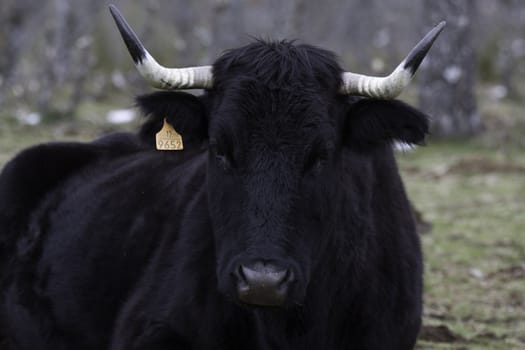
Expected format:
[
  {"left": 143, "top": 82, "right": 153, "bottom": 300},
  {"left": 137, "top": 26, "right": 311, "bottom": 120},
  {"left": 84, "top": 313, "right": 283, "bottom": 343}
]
[{"left": 419, "top": 0, "right": 481, "bottom": 137}]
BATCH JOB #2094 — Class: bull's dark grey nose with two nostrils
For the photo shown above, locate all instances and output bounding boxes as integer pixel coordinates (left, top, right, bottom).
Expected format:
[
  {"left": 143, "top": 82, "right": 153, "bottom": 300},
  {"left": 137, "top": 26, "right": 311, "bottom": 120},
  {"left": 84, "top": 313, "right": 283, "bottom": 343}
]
[{"left": 237, "top": 262, "right": 294, "bottom": 306}]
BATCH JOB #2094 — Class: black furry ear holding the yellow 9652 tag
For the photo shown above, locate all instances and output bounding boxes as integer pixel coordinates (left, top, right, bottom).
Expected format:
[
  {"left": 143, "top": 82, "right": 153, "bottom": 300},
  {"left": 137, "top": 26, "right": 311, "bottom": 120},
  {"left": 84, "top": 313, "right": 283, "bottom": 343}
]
[{"left": 136, "top": 91, "right": 208, "bottom": 148}]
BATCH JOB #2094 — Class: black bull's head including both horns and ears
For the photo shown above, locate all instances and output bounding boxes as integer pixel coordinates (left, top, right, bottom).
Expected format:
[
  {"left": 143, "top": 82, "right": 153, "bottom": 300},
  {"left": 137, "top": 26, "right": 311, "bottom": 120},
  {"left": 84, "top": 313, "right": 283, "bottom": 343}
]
[{"left": 111, "top": 7, "right": 444, "bottom": 306}]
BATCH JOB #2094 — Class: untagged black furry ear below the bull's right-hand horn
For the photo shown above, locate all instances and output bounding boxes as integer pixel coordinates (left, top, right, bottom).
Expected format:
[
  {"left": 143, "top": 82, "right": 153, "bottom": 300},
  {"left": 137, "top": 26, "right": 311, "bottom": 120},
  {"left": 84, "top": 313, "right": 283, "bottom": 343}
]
[{"left": 344, "top": 99, "right": 429, "bottom": 147}]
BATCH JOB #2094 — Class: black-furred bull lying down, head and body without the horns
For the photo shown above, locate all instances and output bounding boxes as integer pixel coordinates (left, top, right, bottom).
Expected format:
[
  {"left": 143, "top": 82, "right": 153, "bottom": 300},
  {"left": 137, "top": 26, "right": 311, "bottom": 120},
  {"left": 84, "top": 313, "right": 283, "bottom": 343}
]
[{"left": 0, "top": 24, "right": 428, "bottom": 350}]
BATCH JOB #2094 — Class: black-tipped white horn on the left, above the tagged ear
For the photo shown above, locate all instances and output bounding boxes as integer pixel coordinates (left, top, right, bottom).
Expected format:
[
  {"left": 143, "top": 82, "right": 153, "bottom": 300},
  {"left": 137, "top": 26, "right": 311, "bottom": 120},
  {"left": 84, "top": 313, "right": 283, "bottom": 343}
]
[{"left": 109, "top": 5, "right": 213, "bottom": 90}]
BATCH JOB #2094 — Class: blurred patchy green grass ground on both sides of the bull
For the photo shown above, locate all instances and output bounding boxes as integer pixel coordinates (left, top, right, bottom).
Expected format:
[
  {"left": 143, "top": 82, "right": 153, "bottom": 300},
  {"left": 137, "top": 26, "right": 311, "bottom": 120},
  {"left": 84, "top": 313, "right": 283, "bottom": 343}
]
[{"left": 0, "top": 94, "right": 525, "bottom": 350}]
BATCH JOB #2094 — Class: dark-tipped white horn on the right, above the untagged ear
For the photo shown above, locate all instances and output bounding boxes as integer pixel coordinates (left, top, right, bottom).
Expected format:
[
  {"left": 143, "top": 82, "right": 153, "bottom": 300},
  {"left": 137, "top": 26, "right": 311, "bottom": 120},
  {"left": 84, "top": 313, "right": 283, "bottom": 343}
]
[{"left": 339, "top": 21, "right": 446, "bottom": 99}]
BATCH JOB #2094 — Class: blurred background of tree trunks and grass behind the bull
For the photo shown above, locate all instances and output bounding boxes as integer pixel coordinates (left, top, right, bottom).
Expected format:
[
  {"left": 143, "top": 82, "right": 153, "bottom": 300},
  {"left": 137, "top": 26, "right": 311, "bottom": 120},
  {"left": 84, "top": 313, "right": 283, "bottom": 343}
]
[{"left": 0, "top": 0, "right": 525, "bottom": 349}]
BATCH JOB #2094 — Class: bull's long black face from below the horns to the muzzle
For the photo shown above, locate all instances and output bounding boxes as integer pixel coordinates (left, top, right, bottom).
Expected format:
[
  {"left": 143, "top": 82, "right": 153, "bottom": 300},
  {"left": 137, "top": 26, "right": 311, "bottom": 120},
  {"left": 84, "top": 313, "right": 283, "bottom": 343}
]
[{"left": 203, "top": 63, "right": 339, "bottom": 306}]
